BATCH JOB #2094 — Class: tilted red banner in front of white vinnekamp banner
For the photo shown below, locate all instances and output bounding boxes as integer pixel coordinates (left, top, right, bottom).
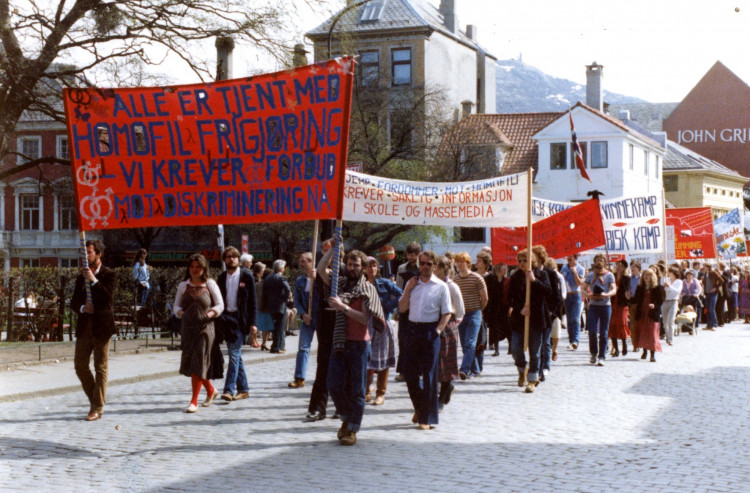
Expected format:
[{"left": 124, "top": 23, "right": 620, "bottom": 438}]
[{"left": 492, "top": 200, "right": 605, "bottom": 265}]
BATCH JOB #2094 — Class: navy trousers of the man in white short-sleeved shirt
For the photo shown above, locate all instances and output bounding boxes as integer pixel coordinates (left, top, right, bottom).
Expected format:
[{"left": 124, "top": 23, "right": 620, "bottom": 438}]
[{"left": 402, "top": 322, "right": 440, "bottom": 425}]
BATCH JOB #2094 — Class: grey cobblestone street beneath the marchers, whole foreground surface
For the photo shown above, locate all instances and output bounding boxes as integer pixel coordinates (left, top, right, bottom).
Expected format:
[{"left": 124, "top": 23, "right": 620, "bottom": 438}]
[{"left": 0, "top": 323, "right": 750, "bottom": 492}]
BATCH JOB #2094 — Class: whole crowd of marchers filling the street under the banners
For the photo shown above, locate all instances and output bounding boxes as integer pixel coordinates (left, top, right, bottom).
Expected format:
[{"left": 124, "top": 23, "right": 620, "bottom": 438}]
[{"left": 71, "top": 237, "right": 750, "bottom": 445}]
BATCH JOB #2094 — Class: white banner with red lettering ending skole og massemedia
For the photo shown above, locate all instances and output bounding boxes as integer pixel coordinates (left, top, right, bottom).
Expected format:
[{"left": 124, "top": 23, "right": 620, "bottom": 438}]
[{"left": 344, "top": 170, "right": 528, "bottom": 228}]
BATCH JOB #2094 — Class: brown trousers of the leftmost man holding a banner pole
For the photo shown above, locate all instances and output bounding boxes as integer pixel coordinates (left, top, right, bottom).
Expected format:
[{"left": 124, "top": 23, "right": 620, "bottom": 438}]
[{"left": 73, "top": 315, "right": 110, "bottom": 414}]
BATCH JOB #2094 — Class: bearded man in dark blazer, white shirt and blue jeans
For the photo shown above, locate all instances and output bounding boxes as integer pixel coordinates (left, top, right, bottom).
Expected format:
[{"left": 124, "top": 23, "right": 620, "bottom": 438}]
[{"left": 216, "top": 246, "right": 258, "bottom": 402}]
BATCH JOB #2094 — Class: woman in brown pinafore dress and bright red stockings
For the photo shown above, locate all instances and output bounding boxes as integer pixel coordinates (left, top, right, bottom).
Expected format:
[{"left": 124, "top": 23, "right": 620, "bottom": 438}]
[{"left": 174, "top": 253, "right": 224, "bottom": 413}]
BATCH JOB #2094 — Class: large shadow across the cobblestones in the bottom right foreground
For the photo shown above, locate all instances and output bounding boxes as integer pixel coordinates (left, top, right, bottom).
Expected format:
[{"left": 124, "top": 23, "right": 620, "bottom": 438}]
[{"left": 138, "top": 367, "right": 750, "bottom": 492}]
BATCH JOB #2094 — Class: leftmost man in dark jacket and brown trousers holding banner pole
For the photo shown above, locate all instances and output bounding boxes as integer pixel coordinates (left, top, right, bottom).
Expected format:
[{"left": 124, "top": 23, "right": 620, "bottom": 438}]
[{"left": 70, "top": 240, "right": 116, "bottom": 421}]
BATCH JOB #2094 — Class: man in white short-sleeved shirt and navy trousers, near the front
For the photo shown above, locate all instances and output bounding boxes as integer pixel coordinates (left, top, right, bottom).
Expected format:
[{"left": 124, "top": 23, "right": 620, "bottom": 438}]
[{"left": 398, "top": 250, "right": 453, "bottom": 430}]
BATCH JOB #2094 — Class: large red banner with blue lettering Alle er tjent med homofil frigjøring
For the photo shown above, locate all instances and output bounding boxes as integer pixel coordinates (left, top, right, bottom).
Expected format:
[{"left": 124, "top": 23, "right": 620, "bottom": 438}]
[{"left": 63, "top": 57, "right": 354, "bottom": 230}]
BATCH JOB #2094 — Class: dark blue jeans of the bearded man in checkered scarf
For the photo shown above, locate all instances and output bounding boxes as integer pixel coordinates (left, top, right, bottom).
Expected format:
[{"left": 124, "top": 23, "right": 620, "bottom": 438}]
[{"left": 328, "top": 341, "right": 370, "bottom": 433}]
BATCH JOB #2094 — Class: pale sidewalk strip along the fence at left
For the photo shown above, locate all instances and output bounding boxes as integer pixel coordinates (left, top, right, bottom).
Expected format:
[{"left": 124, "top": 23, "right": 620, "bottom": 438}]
[{"left": 0, "top": 335, "right": 317, "bottom": 402}]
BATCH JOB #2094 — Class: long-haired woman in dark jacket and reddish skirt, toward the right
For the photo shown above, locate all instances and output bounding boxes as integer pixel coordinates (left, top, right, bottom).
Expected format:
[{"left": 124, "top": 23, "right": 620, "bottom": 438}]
[{"left": 634, "top": 268, "right": 664, "bottom": 362}]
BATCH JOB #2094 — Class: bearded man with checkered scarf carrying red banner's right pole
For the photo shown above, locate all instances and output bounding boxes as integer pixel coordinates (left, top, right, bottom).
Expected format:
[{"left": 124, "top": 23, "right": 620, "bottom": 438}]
[{"left": 321, "top": 242, "right": 385, "bottom": 445}]
